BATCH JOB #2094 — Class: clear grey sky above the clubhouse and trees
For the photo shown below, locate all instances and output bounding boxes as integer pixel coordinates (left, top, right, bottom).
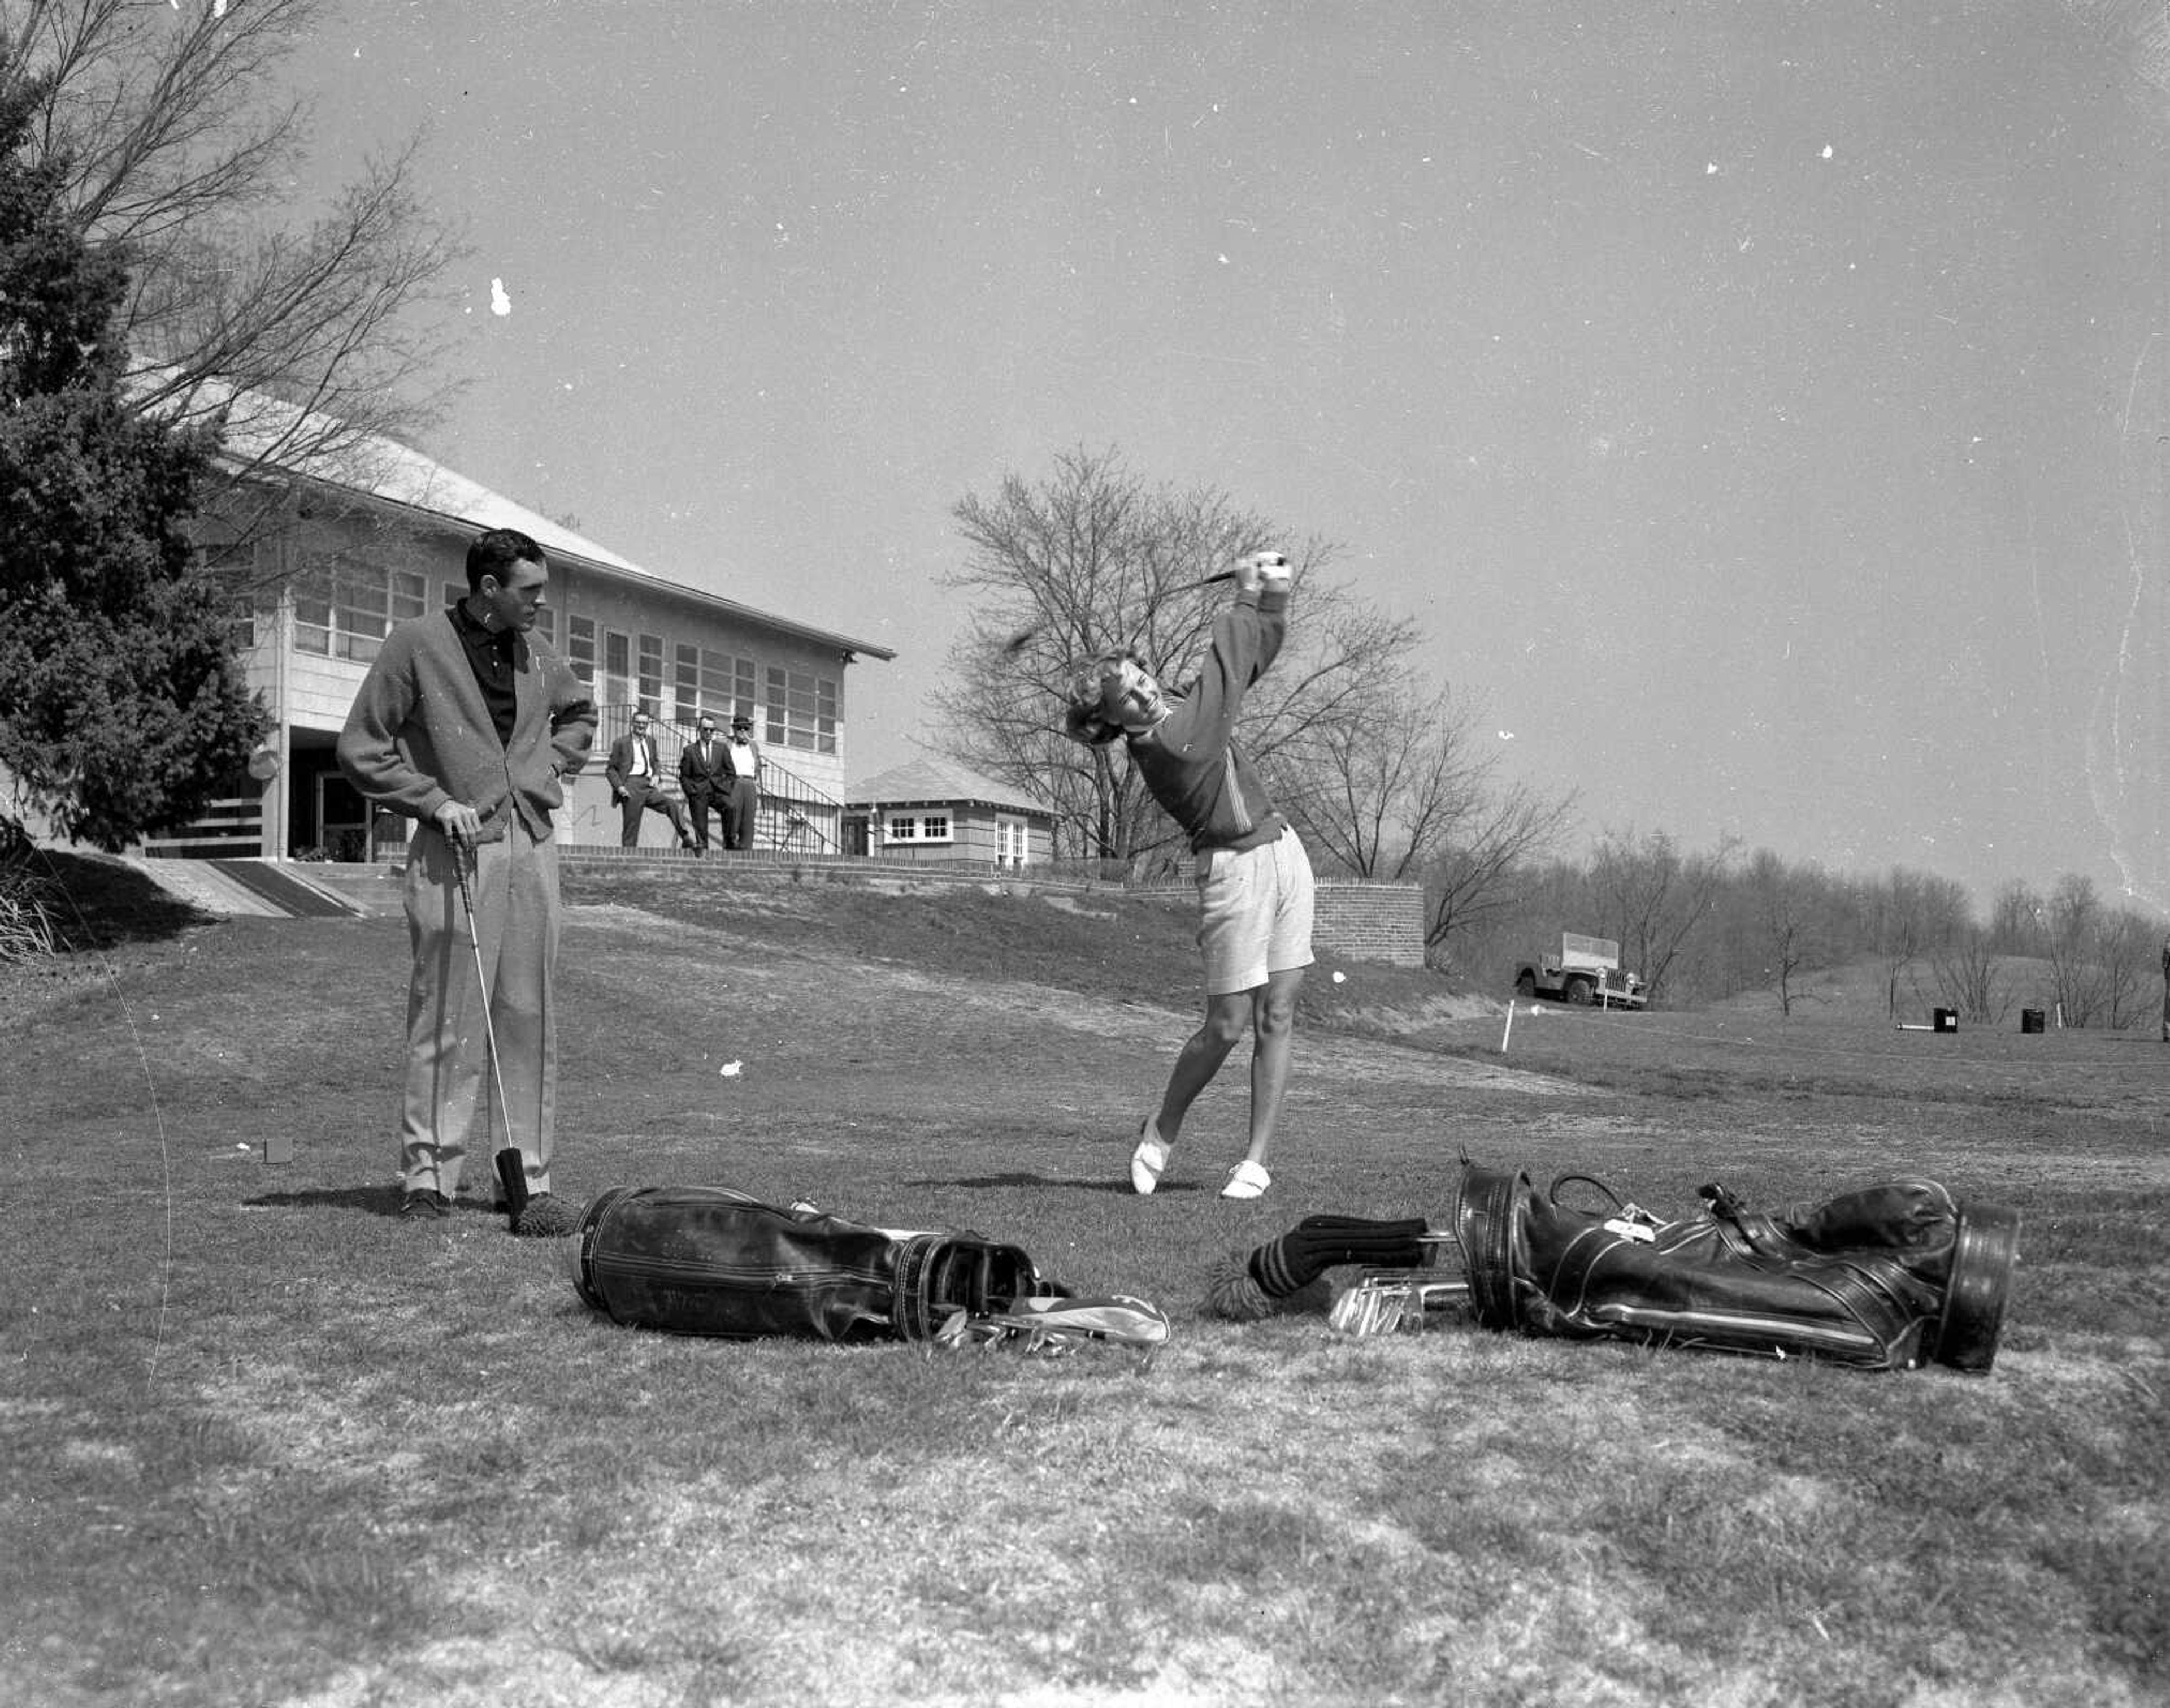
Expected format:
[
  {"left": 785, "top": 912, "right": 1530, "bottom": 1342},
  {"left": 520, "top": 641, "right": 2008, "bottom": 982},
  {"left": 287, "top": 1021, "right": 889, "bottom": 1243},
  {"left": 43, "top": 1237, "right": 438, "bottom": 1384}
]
[{"left": 291, "top": 0, "right": 2170, "bottom": 912}]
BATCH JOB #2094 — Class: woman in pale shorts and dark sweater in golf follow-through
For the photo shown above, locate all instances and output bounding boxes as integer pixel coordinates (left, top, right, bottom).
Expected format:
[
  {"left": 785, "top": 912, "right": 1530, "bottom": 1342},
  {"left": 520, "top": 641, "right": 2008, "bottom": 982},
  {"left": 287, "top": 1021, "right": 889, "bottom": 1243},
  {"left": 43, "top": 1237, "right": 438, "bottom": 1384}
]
[{"left": 1064, "top": 551, "right": 1313, "bottom": 1198}]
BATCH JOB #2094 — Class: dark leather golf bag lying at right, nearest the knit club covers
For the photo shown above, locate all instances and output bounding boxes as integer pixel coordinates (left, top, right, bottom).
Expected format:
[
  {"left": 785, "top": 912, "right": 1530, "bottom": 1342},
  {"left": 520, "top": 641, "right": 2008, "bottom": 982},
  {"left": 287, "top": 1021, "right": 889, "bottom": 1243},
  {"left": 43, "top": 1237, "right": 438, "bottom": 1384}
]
[{"left": 1454, "top": 1165, "right": 2020, "bottom": 1372}]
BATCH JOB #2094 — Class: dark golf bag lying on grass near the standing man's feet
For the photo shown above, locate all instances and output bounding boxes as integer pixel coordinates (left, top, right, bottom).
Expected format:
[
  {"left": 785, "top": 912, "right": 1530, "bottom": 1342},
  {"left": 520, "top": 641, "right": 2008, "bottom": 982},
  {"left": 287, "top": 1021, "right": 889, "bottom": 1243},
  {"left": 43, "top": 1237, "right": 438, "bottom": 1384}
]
[{"left": 568, "top": 1187, "right": 1064, "bottom": 1341}]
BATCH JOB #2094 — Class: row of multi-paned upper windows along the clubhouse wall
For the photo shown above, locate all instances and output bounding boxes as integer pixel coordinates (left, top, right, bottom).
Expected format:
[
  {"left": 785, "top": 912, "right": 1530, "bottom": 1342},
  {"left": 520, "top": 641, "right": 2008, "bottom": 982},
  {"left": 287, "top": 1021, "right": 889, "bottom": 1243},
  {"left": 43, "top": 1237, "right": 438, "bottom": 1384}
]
[{"left": 293, "top": 564, "right": 837, "bottom": 751}]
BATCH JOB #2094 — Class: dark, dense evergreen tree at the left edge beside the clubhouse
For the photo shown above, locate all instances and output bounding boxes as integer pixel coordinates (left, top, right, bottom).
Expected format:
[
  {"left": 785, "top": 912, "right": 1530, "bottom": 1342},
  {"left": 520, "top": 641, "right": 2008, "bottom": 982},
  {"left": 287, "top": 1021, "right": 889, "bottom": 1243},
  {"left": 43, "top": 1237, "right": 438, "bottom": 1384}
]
[{"left": 0, "top": 41, "right": 263, "bottom": 851}]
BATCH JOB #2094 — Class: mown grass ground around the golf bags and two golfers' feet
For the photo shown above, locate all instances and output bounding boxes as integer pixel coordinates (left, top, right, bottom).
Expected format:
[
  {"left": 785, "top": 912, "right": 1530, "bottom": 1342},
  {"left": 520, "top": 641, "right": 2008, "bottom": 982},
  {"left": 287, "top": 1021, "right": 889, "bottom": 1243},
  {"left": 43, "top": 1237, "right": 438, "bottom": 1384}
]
[{"left": 0, "top": 868, "right": 2170, "bottom": 1708}]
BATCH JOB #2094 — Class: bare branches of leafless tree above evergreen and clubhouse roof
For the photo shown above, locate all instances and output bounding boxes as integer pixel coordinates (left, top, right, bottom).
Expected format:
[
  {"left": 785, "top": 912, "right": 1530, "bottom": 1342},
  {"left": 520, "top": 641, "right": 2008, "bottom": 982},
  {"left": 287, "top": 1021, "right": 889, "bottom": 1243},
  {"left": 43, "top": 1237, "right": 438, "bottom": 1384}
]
[{"left": 0, "top": 0, "right": 458, "bottom": 538}]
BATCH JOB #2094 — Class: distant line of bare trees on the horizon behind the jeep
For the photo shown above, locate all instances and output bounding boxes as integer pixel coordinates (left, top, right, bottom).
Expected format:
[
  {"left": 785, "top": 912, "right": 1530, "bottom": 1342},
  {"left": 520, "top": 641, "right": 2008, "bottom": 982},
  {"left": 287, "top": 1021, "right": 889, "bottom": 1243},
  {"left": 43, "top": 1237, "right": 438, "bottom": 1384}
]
[{"left": 1430, "top": 831, "right": 2165, "bottom": 1029}]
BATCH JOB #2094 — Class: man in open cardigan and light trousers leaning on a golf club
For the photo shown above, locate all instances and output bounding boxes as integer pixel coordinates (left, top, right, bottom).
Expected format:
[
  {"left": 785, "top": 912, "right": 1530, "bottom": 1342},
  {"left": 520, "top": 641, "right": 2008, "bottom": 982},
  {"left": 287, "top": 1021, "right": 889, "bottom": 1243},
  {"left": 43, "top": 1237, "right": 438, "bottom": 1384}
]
[{"left": 338, "top": 527, "right": 597, "bottom": 1235}]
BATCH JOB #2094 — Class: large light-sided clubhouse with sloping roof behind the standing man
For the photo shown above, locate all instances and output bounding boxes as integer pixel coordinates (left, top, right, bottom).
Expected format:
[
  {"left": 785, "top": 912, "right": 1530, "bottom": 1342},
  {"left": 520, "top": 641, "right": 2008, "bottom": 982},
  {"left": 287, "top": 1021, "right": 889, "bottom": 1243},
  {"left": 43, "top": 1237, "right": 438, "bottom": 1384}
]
[{"left": 158, "top": 395, "right": 896, "bottom": 861}]
